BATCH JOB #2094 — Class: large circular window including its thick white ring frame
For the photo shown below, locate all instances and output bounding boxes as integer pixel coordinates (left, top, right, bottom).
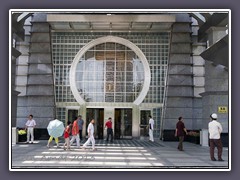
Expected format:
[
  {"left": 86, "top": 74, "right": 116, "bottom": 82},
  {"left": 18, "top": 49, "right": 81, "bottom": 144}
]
[{"left": 70, "top": 36, "right": 150, "bottom": 104}]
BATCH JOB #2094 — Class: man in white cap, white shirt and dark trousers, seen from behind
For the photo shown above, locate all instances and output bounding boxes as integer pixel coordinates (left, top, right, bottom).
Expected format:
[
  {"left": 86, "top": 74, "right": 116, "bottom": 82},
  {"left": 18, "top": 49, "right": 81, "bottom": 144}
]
[{"left": 208, "top": 113, "right": 223, "bottom": 161}]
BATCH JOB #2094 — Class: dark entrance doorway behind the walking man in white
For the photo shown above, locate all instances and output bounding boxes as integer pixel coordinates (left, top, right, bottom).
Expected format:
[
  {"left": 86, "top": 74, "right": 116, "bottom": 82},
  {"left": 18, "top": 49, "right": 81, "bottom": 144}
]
[{"left": 86, "top": 108, "right": 104, "bottom": 139}]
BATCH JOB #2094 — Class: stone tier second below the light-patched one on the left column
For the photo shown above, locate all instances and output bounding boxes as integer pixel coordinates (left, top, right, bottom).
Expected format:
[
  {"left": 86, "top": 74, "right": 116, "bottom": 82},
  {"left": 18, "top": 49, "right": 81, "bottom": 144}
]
[{"left": 27, "top": 85, "right": 54, "bottom": 96}]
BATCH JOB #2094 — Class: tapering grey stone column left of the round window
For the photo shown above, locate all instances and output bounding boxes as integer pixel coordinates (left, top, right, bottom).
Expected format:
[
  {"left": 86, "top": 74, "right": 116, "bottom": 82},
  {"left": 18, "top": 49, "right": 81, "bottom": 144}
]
[{"left": 25, "top": 14, "right": 55, "bottom": 128}]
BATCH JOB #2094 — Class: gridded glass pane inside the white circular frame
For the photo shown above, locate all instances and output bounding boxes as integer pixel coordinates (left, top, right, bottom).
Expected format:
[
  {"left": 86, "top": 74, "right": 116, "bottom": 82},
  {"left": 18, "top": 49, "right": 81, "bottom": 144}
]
[{"left": 75, "top": 42, "right": 144, "bottom": 102}]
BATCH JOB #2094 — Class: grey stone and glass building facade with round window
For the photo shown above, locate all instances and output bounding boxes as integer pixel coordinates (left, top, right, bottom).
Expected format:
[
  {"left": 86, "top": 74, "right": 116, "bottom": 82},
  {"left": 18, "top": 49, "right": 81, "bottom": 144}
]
[{"left": 14, "top": 12, "right": 229, "bottom": 143}]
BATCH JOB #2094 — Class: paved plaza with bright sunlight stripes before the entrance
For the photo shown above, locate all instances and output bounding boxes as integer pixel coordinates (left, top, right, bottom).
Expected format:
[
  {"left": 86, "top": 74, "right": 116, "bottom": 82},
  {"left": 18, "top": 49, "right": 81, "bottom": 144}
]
[{"left": 11, "top": 139, "right": 229, "bottom": 169}]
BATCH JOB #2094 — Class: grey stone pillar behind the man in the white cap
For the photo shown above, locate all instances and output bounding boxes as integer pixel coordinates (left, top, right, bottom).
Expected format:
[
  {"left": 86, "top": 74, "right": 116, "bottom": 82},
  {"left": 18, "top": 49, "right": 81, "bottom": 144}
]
[{"left": 201, "top": 61, "right": 229, "bottom": 132}]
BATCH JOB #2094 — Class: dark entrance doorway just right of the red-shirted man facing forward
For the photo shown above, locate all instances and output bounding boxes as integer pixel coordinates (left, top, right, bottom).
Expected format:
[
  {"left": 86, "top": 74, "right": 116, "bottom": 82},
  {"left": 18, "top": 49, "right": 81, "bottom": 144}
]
[{"left": 114, "top": 109, "right": 132, "bottom": 139}]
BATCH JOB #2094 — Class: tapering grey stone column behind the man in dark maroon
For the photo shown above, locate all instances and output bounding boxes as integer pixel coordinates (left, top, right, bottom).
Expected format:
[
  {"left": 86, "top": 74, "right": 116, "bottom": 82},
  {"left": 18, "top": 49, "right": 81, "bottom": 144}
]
[{"left": 163, "top": 14, "right": 193, "bottom": 138}]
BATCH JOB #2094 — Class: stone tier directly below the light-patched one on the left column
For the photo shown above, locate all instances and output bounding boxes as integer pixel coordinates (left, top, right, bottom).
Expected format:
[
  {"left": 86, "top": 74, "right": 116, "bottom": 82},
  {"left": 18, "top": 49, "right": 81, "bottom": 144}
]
[{"left": 28, "top": 75, "right": 53, "bottom": 85}]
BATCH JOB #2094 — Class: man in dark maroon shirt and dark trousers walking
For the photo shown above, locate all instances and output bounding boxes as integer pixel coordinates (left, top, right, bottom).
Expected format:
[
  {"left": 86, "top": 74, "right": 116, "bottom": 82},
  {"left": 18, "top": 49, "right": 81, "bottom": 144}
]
[{"left": 175, "top": 116, "right": 188, "bottom": 151}]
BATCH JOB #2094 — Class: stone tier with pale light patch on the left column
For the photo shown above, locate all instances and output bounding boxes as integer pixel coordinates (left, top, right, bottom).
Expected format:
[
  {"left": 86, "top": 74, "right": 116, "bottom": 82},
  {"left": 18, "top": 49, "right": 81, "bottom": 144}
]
[{"left": 29, "top": 64, "right": 53, "bottom": 74}]
